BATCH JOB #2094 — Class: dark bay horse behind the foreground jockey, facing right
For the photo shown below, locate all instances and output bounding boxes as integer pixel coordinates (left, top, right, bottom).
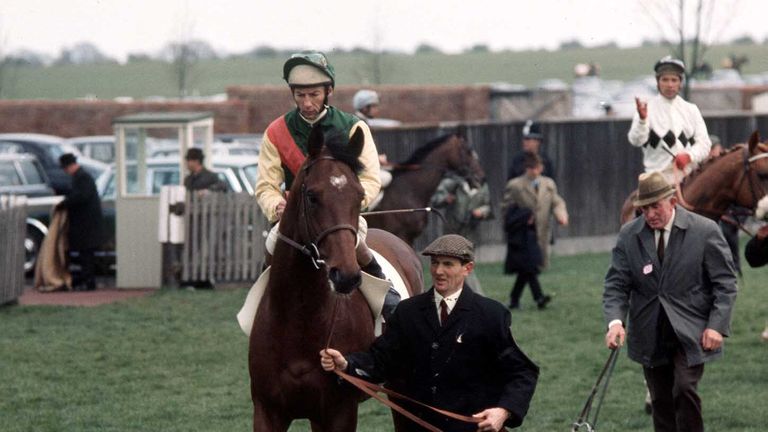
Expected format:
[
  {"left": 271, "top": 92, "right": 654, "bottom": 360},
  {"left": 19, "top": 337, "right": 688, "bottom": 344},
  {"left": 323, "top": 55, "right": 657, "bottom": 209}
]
[{"left": 366, "top": 131, "right": 485, "bottom": 245}]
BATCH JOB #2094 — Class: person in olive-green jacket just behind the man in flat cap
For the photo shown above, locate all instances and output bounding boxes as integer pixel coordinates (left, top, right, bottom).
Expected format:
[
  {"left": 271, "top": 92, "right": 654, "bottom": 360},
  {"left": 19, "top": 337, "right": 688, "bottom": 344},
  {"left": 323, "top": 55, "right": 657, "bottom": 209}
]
[{"left": 430, "top": 173, "right": 492, "bottom": 294}]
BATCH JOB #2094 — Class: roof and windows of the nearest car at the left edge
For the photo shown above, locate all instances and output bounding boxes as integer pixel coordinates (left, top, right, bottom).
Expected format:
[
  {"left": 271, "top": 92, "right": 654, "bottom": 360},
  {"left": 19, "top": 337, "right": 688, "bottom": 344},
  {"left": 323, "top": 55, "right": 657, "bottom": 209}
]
[{"left": 0, "top": 154, "right": 53, "bottom": 197}]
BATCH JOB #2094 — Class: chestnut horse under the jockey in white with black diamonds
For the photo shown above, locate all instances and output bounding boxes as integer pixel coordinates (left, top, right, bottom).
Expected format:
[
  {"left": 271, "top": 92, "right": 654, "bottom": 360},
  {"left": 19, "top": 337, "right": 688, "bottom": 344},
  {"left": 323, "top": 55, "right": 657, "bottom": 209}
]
[{"left": 621, "top": 131, "right": 768, "bottom": 224}]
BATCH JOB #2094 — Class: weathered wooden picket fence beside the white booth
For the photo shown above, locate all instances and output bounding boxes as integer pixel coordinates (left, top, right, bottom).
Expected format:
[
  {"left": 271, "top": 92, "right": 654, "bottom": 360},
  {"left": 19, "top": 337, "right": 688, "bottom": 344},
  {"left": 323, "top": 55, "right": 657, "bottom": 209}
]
[{"left": 181, "top": 193, "right": 269, "bottom": 282}]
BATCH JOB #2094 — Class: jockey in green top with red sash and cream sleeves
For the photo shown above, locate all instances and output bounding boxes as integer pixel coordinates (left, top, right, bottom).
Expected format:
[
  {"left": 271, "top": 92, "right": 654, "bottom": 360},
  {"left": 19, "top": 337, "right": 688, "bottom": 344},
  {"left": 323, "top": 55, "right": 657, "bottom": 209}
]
[{"left": 255, "top": 51, "right": 399, "bottom": 319}]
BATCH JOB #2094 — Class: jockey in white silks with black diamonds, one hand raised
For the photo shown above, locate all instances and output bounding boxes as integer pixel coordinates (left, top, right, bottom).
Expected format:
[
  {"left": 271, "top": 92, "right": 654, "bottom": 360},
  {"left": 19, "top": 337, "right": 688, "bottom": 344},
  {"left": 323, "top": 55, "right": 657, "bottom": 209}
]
[{"left": 627, "top": 56, "right": 712, "bottom": 181}]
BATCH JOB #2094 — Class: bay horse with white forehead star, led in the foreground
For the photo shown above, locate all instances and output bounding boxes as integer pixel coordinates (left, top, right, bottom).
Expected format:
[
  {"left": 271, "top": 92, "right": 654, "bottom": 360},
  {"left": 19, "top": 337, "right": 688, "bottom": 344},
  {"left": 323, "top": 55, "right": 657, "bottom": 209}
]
[{"left": 248, "top": 128, "right": 424, "bottom": 432}]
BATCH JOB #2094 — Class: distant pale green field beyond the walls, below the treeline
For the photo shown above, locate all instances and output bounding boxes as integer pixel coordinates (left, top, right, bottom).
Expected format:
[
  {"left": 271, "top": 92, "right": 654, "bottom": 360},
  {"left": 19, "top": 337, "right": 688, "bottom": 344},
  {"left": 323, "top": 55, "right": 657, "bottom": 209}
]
[{"left": 0, "top": 45, "right": 768, "bottom": 99}]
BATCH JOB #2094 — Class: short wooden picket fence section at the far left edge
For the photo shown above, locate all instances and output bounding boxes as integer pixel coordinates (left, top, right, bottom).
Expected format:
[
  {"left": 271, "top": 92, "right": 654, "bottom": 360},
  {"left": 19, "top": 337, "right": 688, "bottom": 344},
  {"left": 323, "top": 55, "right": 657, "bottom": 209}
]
[{"left": 0, "top": 196, "right": 27, "bottom": 305}]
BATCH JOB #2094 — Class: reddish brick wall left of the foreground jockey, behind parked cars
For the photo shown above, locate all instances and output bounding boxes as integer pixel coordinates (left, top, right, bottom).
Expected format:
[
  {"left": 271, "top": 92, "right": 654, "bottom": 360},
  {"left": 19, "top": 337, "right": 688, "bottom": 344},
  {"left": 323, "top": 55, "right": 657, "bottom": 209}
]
[{"left": 0, "top": 100, "right": 250, "bottom": 138}]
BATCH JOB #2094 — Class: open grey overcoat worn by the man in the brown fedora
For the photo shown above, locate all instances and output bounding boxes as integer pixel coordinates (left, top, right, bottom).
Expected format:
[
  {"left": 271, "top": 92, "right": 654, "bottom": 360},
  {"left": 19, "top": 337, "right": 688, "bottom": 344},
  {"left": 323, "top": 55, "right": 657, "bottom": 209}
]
[{"left": 603, "top": 206, "right": 736, "bottom": 366}]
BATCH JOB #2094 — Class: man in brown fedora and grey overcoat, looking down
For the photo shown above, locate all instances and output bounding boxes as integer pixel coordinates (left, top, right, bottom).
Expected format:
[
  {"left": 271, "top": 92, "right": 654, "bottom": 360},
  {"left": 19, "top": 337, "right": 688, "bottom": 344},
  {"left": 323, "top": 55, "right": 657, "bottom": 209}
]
[{"left": 603, "top": 172, "right": 736, "bottom": 432}]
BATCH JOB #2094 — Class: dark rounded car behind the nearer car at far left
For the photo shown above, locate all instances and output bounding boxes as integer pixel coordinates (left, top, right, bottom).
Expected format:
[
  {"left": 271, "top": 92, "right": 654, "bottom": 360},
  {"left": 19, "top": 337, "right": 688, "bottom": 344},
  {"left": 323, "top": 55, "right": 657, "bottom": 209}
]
[{"left": 0, "top": 133, "right": 107, "bottom": 194}]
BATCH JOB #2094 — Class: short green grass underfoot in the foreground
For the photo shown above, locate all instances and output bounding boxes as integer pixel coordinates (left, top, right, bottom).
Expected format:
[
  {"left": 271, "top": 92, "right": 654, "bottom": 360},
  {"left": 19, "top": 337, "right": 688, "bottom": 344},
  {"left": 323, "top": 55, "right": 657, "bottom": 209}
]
[{"left": 0, "top": 254, "right": 768, "bottom": 432}]
